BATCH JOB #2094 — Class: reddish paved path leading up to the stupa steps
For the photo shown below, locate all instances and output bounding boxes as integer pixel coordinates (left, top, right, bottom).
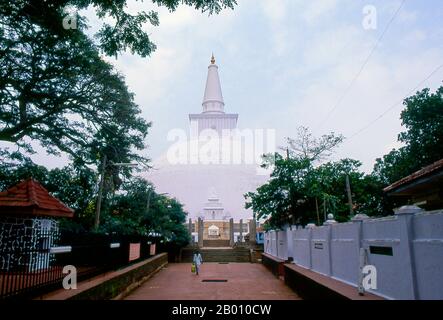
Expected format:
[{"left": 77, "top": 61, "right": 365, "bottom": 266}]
[{"left": 126, "top": 263, "right": 299, "bottom": 300}]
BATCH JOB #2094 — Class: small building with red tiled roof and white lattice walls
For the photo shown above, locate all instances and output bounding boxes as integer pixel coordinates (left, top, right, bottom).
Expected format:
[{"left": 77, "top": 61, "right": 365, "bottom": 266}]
[{"left": 0, "top": 179, "right": 74, "bottom": 271}]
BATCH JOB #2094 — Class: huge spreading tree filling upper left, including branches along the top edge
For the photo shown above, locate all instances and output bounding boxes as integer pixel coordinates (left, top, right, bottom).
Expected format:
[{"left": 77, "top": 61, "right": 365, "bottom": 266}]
[{"left": 0, "top": 0, "right": 235, "bottom": 168}]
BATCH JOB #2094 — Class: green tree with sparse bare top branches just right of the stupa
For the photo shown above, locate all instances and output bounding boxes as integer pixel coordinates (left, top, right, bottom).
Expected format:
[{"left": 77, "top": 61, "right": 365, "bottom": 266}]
[{"left": 245, "top": 127, "right": 368, "bottom": 227}]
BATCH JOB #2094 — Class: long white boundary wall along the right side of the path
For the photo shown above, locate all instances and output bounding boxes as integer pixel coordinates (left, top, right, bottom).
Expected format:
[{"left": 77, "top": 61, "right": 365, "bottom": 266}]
[{"left": 264, "top": 206, "right": 443, "bottom": 299}]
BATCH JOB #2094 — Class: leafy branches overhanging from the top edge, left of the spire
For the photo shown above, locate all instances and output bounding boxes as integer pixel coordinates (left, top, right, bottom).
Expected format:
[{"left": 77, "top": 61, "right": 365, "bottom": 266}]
[{"left": 0, "top": 0, "right": 237, "bottom": 57}]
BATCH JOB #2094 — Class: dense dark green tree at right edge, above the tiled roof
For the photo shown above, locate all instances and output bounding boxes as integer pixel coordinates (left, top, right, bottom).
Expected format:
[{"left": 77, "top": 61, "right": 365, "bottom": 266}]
[{"left": 373, "top": 87, "right": 443, "bottom": 186}]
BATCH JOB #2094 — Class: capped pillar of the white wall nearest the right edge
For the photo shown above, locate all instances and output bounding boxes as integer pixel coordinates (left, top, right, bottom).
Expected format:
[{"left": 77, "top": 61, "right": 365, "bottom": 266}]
[{"left": 395, "top": 206, "right": 423, "bottom": 300}]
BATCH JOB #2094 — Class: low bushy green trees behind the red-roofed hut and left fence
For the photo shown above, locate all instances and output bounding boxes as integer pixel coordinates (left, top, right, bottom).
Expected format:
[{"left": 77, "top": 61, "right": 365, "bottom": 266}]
[{"left": 0, "top": 157, "right": 189, "bottom": 245}]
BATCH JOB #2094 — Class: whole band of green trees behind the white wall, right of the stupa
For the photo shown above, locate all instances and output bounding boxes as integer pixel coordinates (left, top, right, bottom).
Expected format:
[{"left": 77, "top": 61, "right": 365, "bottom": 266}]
[{"left": 245, "top": 87, "right": 443, "bottom": 228}]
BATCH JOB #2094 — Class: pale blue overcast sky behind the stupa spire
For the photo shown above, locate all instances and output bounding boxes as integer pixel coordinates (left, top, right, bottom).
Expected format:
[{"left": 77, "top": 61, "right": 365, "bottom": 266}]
[{"left": 4, "top": 0, "right": 443, "bottom": 171}]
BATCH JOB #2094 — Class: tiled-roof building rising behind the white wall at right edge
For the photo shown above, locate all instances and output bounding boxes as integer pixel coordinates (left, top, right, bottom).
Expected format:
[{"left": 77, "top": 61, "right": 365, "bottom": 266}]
[{"left": 383, "top": 159, "right": 443, "bottom": 210}]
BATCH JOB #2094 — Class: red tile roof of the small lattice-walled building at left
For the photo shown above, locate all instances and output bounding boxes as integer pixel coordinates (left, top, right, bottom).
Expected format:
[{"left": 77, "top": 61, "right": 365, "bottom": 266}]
[{"left": 0, "top": 179, "right": 74, "bottom": 218}]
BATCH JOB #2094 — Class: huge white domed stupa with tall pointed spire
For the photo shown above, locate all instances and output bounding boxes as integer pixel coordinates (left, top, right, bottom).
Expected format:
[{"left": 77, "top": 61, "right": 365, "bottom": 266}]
[{"left": 145, "top": 56, "right": 275, "bottom": 220}]
